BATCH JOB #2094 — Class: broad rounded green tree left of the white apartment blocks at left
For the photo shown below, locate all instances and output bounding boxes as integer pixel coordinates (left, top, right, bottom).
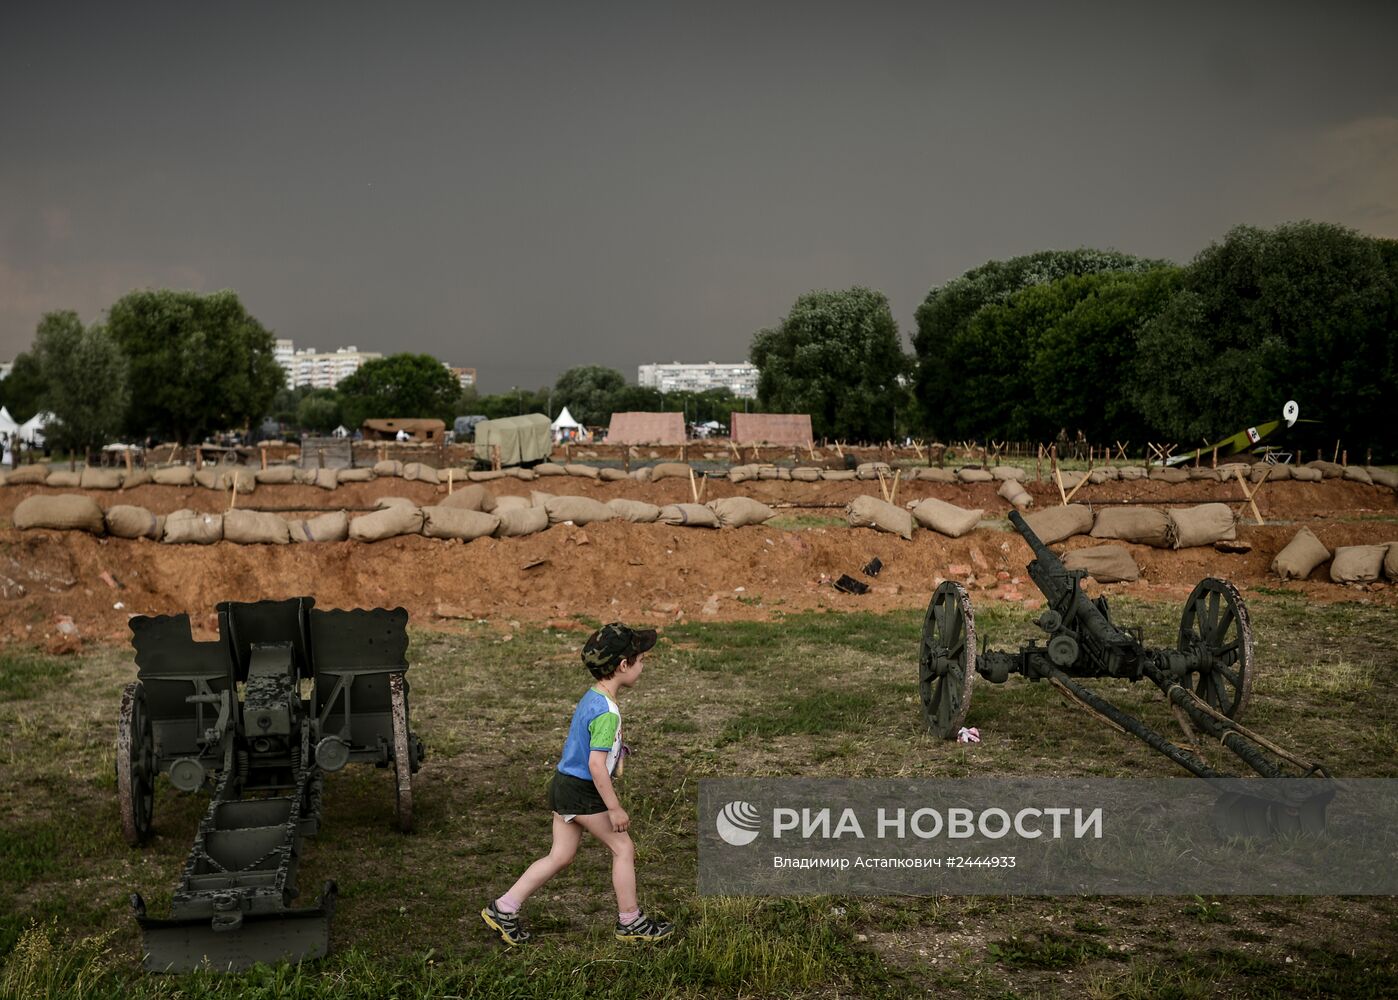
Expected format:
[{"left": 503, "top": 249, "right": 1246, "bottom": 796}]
[{"left": 106, "top": 290, "right": 285, "bottom": 442}]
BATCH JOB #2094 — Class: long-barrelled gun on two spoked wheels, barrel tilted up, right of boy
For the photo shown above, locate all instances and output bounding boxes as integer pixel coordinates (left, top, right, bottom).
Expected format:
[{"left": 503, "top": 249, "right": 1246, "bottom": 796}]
[{"left": 918, "top": 510, "right": 1335, "bottom": 835}]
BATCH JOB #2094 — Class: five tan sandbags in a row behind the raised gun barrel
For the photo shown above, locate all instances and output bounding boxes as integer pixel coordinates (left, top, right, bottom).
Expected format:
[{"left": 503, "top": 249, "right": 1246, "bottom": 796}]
[{"left": 844, "top": 497, "right": 1237, "bottom": 548}]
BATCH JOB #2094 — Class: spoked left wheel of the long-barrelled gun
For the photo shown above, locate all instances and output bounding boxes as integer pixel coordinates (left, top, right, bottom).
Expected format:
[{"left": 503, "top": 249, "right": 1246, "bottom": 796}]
[{"left": 918, "top": 580, "right": 976, "bottom": 740}]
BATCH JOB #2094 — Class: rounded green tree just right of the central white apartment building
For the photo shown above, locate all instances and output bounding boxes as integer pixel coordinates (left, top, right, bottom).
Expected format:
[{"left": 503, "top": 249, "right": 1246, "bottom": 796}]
[{"left": 751, "top": 287, "right": 909, "bottom": 441}]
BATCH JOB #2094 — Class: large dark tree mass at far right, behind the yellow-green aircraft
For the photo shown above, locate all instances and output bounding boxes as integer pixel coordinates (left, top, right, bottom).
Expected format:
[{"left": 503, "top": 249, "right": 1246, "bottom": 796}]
[{"left": 1135, "top": 222, "right": 1398, "bottom": 455}]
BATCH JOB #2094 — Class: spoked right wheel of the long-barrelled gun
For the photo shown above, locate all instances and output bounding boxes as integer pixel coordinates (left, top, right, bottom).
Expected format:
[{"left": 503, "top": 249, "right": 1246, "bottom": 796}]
[{"left": 1180, "top": 578, "right": 1253, "bottom": 719}]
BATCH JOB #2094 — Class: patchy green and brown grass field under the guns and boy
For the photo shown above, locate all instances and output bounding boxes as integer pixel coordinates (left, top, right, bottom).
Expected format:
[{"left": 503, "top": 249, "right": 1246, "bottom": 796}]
[{"left": 0, "top": 590, "right": 1398, "bottom": 997}]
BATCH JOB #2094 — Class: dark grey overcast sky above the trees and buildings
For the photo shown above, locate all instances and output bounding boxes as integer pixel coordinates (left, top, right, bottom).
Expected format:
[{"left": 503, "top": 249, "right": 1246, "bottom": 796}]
[{"left": 0, "top": 1, "right": 1398, "bottom": 392}]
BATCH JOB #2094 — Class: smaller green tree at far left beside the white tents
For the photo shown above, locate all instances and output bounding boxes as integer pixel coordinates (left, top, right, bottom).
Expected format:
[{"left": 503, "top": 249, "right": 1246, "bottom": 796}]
[{"left": 34, "top": 312, "right": 130, "bottom": 453}]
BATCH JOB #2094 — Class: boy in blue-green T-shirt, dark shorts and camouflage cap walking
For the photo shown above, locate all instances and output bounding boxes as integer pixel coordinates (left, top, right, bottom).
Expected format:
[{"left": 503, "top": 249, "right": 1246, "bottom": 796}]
[{"left": 481, "top": 621, "right": 675, "bottom": 944}]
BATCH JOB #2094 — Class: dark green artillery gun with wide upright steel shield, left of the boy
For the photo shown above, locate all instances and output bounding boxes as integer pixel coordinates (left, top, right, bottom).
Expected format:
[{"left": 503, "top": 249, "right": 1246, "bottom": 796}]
[{"left": 116, "top": 597, "right": 424, "bottom": 972}]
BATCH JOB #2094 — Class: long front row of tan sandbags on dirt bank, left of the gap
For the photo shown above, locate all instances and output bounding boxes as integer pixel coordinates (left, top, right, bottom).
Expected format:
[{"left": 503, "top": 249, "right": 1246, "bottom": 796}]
[{"left": 5, "top": 487, "right": 776, "bottom": 544}]
